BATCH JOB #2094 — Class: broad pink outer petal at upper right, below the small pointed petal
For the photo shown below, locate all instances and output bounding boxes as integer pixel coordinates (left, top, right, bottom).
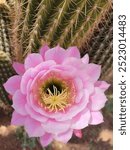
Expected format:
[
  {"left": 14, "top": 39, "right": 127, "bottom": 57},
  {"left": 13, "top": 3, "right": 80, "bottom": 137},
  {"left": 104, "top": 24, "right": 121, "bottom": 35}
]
[{"left": 86, "top": 64, "right": 101, "bottom": 82}]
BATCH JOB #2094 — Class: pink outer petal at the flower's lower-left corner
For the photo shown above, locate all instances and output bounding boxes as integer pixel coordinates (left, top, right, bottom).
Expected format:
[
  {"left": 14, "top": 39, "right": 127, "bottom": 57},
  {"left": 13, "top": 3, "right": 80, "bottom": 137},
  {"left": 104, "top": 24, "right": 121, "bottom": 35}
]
[{"left": 11, "top": 111, "right": 26, "bottom": 126}]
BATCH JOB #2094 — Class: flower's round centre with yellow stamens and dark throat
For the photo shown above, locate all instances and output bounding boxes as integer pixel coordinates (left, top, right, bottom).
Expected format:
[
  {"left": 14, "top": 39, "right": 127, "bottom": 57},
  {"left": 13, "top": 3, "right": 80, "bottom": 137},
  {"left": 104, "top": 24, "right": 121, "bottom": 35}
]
[{"left": 40, "top": 78, "right": 73, "bottom": 112}]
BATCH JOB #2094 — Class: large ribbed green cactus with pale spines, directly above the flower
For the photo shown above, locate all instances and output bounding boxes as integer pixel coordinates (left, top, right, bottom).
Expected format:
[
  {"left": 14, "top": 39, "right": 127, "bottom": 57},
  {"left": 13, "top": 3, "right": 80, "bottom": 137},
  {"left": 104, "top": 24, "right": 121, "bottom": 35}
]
[{"left": 8, "top": 0, "right": 112, "bottom": 61}]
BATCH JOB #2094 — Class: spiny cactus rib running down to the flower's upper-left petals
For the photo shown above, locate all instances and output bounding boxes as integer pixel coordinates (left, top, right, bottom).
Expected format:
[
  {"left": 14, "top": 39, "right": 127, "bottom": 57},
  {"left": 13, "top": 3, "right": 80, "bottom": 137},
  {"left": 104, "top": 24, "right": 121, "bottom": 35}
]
[{"left": 23, "top": 0, "right": 54, "bottom": 56}]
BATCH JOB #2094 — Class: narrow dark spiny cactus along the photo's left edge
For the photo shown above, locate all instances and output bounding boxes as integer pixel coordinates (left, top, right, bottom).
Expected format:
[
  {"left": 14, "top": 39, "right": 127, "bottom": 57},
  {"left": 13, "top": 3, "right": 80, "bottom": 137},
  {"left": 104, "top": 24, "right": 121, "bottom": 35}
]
[{"left": 0, "top": 3, "right": 15, "bottom": 104}]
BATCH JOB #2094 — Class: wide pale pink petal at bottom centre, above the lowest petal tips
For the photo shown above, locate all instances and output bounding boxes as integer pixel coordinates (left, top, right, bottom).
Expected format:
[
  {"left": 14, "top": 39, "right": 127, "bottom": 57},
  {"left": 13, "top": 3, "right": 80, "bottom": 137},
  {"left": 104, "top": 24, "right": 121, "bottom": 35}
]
[{"left": 42, "top": 120, "right": 70, "bottom": 134}]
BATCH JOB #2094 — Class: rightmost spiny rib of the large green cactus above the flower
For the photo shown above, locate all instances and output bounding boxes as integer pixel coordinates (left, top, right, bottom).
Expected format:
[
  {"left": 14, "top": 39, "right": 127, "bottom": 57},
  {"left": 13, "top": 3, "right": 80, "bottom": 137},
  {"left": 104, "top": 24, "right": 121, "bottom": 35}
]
[{"left": 67, "top": 0, "right": 111, "bottom": 48}]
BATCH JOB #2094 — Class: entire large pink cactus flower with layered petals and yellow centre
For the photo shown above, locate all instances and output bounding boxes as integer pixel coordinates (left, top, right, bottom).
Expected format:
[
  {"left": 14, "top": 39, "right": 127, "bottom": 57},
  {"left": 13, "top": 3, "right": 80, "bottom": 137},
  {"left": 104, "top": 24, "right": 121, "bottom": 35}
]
[{"left": 4, "top": 46, "right": 109, "bottom": 146}]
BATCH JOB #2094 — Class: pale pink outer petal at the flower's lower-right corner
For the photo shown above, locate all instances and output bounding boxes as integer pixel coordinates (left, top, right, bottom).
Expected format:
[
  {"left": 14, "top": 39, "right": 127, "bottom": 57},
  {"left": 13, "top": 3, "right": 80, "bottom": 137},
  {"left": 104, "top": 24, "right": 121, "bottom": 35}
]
[{"left": 89, "top": 111, "right": 103, "bottom": 125}]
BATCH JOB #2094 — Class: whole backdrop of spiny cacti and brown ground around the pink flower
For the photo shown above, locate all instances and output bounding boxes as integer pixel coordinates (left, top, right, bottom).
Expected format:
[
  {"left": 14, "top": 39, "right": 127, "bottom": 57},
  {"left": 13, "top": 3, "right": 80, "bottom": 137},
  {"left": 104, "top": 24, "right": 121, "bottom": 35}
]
[{"left": 0, "top": 0, "right": 113, "bottom": 150}]
